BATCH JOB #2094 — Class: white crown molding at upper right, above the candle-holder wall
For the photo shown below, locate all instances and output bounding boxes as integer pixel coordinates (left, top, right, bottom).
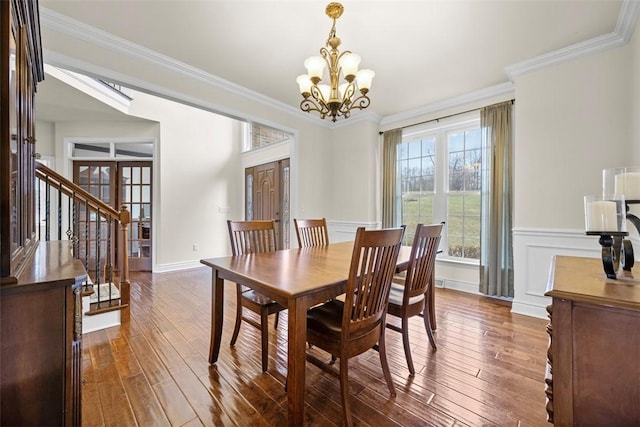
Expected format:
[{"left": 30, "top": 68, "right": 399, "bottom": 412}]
[{"left": 505, "top": 0, "right": 640, "bottom": 81}]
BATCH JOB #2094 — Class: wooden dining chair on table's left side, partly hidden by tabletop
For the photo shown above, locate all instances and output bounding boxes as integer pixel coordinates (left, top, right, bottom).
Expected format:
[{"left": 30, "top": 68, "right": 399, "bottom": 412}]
[{"left": 227, "top": 220, "right": 285, "bottom": 372}]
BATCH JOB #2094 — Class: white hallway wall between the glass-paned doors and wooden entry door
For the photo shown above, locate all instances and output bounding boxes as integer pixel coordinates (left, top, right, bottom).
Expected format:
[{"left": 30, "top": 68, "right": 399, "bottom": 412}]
[{"left": 124, "top": 93, "right": 243, "bottom": 271}]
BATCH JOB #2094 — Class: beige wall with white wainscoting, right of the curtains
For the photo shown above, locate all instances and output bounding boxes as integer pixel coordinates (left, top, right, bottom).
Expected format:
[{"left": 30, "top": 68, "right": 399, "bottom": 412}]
[{"left": 513, "top": 46, "right": 637, "bottom": 317}]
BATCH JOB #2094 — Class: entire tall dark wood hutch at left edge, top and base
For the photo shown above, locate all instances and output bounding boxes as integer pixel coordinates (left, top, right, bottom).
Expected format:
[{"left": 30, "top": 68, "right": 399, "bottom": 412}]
[{"left": 0, "top": 0, "right": 81, "bottom": 426}]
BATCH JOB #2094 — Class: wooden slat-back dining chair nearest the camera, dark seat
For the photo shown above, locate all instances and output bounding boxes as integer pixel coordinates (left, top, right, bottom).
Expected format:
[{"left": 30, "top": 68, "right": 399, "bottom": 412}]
[{"left": 307, "top": 227, "right": 404, "bottom": 426}]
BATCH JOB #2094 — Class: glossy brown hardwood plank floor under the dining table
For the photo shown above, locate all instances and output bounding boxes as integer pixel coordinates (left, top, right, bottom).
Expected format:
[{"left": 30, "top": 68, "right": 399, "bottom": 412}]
[{"left": 82, "top": 267, "right": 550, "bottom": 426}]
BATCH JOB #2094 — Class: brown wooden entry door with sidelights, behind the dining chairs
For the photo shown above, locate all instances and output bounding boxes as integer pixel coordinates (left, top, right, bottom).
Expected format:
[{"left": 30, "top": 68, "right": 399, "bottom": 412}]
[{"left": 245, "top": 159, "right": 291, "bottom": 249}]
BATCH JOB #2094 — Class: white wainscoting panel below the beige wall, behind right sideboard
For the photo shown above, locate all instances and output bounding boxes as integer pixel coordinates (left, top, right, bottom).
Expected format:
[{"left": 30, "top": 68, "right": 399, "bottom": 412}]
[{"left": 511, "top": 228, "right": 600, "bottom": 318}]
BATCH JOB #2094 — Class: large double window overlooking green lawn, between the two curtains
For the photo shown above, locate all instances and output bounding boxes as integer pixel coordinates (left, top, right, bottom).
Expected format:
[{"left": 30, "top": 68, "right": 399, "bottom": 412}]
[{"left": 396, "top": 112, "right": 482, "bottom": 260}]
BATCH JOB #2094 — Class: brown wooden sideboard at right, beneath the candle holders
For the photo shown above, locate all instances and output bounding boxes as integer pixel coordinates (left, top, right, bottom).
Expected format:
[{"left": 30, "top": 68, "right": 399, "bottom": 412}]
[{"left": 545, "top": 256, "right": 640, "bottom": 427}]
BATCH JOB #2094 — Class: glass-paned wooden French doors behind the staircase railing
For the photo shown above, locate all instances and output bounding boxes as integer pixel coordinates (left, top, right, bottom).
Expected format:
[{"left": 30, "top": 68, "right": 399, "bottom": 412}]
[{"left": 73, "top": 160, "right": 153, "bottom": 271}]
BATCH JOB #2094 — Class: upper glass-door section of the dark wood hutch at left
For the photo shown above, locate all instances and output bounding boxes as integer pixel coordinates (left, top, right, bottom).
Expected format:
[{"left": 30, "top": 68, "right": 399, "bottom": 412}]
[{"left": 0, "top": 0, "right": 44, "bottom": 283}]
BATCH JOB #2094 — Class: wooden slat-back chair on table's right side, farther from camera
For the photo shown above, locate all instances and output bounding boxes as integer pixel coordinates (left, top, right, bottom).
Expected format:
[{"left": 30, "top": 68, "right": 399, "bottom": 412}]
[{"left": 387, "top": 223, "right": 443, "bottom": 375}]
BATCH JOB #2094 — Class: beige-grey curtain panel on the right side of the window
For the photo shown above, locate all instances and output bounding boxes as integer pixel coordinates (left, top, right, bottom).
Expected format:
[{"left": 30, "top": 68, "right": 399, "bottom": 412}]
[{"left": 480, "top": 101, "right": 513, "bottom": 297}]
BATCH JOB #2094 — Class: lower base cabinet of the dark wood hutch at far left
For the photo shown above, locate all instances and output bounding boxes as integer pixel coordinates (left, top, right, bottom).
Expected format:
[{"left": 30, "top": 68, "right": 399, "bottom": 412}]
[{"left": 0, "top": 241, "right": 86, "bottom": 426}]
